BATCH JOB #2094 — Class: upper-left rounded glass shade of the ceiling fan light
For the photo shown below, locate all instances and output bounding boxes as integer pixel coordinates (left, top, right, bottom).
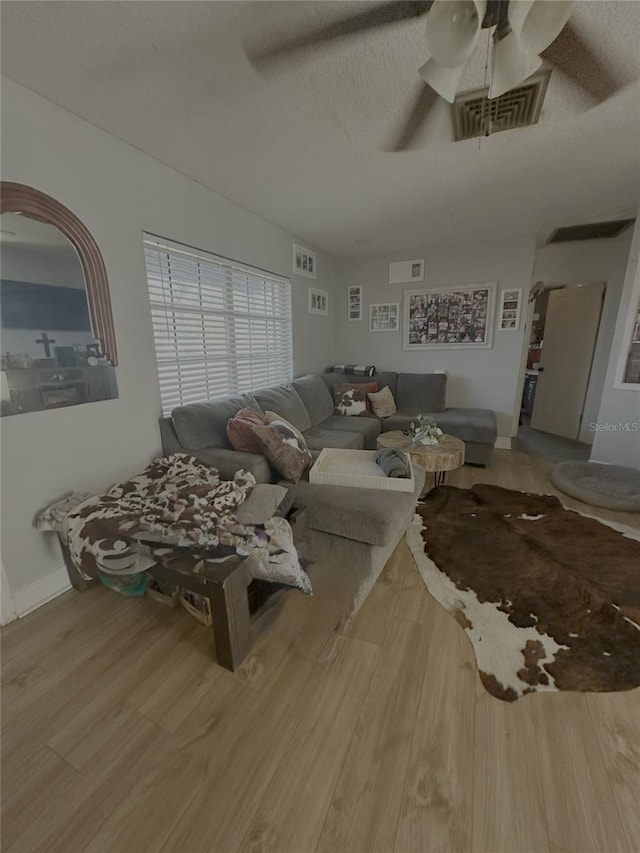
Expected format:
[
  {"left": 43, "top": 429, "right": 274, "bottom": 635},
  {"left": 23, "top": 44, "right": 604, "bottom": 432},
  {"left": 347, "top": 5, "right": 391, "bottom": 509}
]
[{"left": 427, "top": 0, "right": 487, "bottom": 68}]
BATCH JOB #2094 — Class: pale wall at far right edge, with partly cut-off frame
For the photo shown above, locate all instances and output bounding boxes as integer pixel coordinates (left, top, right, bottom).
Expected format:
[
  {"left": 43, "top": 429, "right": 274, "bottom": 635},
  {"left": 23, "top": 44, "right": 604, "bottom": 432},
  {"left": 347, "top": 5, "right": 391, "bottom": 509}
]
[{"left": 591, "top": 210, "right": 640, "bottom": 469}]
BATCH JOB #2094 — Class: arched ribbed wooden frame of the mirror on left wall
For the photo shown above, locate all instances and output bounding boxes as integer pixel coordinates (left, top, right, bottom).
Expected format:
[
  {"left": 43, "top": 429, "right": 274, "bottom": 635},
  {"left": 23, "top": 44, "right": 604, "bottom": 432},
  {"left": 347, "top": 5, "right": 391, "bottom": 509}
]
[{"left": 0, "top": 181, "right": 118, "bottom": 367}]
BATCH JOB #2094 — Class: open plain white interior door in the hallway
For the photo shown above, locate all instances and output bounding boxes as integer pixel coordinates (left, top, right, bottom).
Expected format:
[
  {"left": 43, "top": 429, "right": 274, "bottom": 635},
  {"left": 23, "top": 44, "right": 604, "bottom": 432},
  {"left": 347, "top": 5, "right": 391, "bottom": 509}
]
[{"left": 531, "top": 284, "right": 604, "bottom": 439}]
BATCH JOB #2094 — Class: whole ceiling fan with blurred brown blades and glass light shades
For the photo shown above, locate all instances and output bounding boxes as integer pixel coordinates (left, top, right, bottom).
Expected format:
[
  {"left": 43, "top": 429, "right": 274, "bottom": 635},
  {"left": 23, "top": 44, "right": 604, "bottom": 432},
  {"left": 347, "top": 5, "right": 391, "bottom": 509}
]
[{"left": 248, "top": 0, "right": 621, "bottom": 151}]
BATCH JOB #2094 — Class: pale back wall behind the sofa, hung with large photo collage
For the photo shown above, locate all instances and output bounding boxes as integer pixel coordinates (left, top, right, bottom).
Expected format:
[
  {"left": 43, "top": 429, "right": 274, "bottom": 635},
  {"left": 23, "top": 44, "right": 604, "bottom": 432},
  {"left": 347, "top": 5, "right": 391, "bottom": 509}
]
[{"left": 336, "top": 236, "right": 535, "bottom": 439}]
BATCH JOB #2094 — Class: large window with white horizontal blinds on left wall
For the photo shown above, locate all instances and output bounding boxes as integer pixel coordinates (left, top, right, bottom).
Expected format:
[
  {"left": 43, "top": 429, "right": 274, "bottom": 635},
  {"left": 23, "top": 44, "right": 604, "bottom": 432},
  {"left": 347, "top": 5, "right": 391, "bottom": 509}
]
[{"left": 144, "top": 234, "right": 293, "bottom": 415}]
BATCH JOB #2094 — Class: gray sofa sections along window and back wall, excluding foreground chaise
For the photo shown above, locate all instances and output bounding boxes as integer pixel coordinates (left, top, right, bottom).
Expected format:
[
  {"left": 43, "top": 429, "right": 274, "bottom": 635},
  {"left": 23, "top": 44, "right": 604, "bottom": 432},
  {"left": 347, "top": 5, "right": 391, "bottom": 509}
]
[{"left": 160, "top": 371, "right": 497, "bottom": 476}]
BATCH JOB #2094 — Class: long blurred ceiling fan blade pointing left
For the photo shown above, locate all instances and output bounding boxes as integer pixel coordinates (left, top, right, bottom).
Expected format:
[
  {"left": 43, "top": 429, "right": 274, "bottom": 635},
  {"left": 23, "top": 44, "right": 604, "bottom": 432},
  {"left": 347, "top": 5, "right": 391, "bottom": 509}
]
[{"left": 247, "top": 0, "right": 433, "bottom": 67}]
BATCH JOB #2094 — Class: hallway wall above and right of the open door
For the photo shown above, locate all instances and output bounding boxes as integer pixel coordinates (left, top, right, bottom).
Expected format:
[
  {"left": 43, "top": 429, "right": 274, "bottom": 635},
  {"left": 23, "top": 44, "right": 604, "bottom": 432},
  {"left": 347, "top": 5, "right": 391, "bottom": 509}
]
[{"left": 533, "top": 233, "right": 633, "bottom": 444}]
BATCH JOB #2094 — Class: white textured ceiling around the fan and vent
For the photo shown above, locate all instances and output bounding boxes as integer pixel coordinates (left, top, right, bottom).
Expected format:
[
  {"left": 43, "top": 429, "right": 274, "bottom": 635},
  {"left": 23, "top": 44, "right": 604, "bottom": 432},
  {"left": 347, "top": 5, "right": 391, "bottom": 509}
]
[{"left": 1, "top": 0, "right": 640, "bottom": 255}]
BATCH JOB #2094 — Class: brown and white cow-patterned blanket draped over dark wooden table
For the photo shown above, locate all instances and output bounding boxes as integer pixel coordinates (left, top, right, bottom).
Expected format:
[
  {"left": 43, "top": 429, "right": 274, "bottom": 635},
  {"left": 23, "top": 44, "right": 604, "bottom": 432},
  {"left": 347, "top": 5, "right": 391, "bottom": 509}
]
[{"left": 61, "top": 453, "right": 311, "bottom": 595}]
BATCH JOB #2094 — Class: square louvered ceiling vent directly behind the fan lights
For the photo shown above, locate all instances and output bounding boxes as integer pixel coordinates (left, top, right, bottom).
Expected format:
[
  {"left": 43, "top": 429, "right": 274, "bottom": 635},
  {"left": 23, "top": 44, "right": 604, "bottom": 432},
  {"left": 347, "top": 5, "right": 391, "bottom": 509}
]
[{"left": 452, "top": 69, "right": 551, "bottom": 142}]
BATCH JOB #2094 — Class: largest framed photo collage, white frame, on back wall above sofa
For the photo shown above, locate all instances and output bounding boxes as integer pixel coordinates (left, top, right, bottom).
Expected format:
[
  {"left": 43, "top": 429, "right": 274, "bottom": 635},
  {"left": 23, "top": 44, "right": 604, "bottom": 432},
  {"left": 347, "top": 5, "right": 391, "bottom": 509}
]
[{"left": 402, "top": 282, "right": 497, "bottom": 351}]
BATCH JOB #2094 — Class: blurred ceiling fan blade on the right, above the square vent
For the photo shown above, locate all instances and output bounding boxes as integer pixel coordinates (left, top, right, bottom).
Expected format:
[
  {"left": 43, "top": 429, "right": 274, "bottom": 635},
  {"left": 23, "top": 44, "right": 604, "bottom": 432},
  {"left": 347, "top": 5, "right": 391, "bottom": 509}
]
[{"left": 541, "top": 21, "right": 624, "bottom": 104}]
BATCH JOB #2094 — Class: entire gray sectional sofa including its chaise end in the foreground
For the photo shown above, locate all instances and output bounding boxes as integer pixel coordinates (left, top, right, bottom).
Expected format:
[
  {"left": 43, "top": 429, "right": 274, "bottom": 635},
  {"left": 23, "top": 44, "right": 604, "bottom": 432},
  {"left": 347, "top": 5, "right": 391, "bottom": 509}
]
[{"left": 160, "top": 372, "right": 497, "bottom": 648}]
